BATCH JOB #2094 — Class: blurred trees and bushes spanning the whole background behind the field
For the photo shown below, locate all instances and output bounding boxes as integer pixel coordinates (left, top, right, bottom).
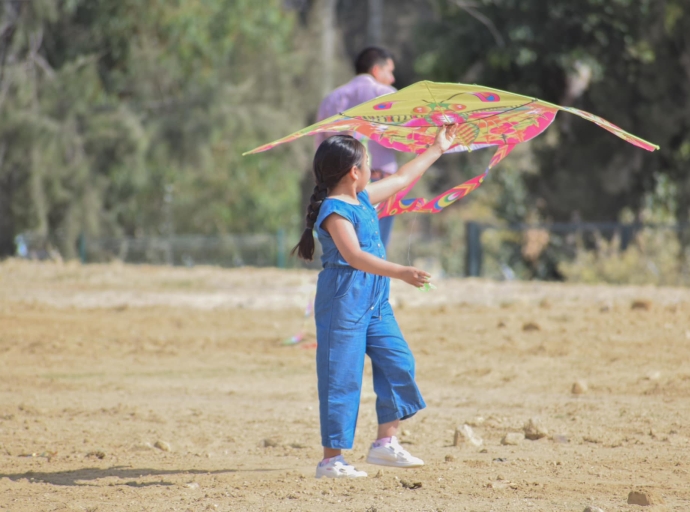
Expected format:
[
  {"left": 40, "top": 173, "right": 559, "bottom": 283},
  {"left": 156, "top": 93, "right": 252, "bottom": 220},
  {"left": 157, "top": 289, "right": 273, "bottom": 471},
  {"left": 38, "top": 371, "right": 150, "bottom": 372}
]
[{"left": 0, "top": 0, "right": 690, "bottom": 284}]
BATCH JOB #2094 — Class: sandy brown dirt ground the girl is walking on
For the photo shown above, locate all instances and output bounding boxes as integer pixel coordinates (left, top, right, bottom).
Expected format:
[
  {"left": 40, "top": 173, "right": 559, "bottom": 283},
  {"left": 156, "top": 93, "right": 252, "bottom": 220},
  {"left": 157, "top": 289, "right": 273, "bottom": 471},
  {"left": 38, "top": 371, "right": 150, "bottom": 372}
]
[{"left": 0, "top": 260, "right": 690, "bottom": 512}]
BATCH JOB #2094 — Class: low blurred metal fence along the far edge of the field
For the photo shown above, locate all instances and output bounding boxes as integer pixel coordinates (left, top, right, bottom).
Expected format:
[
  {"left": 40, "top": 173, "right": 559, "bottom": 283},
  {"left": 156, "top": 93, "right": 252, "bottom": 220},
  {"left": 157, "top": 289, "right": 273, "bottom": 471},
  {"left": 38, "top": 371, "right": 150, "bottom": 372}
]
[{"left": 18, "top": 222, "right": 690, "bottom": 279}]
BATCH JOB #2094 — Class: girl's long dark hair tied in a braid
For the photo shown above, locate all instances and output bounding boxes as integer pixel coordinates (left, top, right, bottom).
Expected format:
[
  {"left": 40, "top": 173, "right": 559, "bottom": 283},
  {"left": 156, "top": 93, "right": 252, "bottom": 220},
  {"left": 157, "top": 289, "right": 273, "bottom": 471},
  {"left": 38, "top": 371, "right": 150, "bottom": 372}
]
[{"left": 290, "top": 135, "right": 366, "bottom": 261}]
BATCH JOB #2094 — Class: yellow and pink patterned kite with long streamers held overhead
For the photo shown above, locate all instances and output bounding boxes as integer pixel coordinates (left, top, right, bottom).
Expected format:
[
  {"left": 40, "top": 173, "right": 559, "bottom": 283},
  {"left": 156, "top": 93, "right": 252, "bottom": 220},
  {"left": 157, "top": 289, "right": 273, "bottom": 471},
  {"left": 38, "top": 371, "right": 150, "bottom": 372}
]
[{"left": 245, "top": 81, "right": 659, "bottom": 217}]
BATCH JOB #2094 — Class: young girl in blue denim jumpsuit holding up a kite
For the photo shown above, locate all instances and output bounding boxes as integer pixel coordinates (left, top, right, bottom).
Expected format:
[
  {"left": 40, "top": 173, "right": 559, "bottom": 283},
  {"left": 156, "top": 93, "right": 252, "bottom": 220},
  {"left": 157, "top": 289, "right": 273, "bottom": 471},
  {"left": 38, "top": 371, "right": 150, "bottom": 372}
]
[{"left": 293, "top": 125, "right": 457, "bottom": 478}]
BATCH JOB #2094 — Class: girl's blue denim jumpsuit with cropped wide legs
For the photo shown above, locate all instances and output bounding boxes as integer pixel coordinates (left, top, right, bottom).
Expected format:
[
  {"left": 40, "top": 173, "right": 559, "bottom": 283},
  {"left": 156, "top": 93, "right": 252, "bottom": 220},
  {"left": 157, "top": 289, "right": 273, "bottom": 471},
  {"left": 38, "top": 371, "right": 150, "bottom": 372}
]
[{"left": 314, "top": 191, "right": 426, "bottom": 449}]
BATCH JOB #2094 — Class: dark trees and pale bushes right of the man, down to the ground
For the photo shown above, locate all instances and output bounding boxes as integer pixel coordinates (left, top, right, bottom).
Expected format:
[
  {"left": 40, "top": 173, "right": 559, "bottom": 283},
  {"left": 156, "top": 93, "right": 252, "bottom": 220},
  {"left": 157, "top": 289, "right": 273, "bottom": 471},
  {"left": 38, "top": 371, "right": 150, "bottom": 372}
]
[{"left": 406, "top": 0, "right": 690, "bottom": 283}]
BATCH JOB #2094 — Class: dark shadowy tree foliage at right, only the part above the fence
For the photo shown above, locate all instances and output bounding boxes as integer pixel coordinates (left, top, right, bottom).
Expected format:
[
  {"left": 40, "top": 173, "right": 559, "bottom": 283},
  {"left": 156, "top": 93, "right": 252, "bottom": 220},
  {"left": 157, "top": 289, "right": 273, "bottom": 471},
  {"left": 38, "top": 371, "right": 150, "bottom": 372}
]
[{"left": 417, "top": 0, "right": 690, "bottom": 225}]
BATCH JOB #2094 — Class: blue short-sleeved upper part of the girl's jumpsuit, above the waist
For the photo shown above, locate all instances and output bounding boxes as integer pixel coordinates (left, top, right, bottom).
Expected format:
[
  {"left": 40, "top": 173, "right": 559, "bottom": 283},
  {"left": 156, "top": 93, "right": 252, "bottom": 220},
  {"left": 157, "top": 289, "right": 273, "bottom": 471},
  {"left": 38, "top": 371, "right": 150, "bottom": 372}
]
[{"left": 314, "top": 190, "right": 386, "bottom": 268}]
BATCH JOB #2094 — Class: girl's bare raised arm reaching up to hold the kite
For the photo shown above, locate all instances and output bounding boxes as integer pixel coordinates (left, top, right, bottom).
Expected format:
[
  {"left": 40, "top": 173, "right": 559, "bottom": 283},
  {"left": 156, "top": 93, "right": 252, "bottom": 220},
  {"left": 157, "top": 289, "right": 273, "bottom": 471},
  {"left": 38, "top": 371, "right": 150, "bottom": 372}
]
[{"left": 366, "top": 124, "right": 458, "bottom": 204}]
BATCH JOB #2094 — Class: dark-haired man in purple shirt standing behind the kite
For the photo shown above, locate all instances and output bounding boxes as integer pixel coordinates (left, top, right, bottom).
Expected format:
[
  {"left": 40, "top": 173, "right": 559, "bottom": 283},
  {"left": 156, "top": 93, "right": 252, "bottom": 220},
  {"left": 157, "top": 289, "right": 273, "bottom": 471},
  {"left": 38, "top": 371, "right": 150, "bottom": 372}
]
[{"left": 315, "top": 46, "right": 398, "bottom": 247}]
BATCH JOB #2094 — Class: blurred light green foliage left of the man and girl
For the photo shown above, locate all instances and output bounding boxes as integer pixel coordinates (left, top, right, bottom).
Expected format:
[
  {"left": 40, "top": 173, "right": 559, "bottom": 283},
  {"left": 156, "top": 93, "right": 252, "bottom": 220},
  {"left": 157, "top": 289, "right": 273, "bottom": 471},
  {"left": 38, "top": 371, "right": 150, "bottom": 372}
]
[{"left": 0, "top": 0, "right": 308, "bottom": 257}]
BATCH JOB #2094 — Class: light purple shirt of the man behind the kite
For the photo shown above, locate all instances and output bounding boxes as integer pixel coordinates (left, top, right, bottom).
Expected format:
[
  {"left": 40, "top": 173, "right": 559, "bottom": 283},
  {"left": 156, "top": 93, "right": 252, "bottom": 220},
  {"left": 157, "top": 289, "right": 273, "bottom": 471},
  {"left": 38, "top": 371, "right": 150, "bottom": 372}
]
[{"left": 314, "top": 73, "right": 398, "bottom": 174}]
